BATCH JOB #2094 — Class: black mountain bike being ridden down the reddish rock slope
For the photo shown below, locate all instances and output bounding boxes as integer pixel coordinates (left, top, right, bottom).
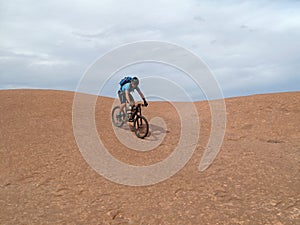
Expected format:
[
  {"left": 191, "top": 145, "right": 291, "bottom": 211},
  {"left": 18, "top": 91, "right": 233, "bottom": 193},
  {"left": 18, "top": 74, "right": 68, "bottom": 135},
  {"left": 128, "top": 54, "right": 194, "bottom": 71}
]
[{"left": 111, "top": 103, "right": 149, "bottom": 139}]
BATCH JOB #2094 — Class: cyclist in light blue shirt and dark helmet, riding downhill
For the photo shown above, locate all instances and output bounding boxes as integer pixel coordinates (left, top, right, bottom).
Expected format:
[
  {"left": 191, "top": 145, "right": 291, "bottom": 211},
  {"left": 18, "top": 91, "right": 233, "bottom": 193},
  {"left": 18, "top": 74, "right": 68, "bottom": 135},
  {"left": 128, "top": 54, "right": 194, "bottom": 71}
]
[{"left": 118, "top": 77, "right": 148, "bottom": 121}]
